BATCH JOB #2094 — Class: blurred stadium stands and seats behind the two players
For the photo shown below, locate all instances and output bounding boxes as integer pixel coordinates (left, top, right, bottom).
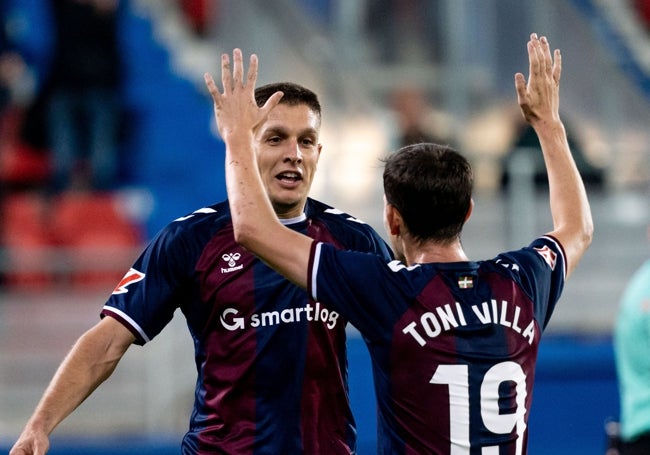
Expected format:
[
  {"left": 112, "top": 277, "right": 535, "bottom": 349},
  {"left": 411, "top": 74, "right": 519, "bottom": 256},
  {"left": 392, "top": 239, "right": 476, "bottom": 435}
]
[{"left": 0, "top": 0, "right": 650, "bottom": 455}]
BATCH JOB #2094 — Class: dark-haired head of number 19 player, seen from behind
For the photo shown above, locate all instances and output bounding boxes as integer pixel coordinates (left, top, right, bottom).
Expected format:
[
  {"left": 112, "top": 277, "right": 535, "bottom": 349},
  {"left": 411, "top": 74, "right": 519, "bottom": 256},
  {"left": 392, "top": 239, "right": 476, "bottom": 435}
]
[{"left": 384, "top": 143, "right": 474, "bottom": 243}]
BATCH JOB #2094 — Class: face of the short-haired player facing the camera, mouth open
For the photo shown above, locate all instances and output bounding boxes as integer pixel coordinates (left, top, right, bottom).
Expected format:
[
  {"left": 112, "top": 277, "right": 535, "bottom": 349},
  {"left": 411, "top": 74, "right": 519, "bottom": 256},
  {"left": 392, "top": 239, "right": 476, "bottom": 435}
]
[{"left": 255, "top": 104, "right": 321, "bottom": 218}]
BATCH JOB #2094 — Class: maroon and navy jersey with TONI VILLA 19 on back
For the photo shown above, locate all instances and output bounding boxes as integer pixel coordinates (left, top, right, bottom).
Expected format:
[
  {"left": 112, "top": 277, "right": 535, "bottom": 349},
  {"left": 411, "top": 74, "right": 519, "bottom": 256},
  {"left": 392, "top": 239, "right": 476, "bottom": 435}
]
[{"left": 308, "top": 236, "right": 566, "bottom": 455}]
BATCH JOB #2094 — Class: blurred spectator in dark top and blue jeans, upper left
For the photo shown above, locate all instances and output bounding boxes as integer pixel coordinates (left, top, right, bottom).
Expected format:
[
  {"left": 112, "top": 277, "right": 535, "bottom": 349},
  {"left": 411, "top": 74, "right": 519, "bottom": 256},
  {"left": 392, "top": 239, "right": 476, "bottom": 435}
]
[{"left": 47, "top": 0, "right": 122, "bottom": 192}]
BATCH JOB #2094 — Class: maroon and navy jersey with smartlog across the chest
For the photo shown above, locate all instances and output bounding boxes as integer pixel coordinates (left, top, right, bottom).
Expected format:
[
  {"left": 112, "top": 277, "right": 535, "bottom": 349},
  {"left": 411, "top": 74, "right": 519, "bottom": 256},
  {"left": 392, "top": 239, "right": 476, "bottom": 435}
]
[{"left": 102, "top": 199, "right": 391, "bottom": 455}]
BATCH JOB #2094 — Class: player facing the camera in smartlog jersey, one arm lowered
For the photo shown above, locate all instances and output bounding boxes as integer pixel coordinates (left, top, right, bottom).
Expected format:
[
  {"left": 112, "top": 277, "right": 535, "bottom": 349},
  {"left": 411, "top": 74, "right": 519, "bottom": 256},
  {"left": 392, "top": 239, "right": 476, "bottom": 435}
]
[{"left": 11, "top": 83, "right": 392, "bottom": 455}]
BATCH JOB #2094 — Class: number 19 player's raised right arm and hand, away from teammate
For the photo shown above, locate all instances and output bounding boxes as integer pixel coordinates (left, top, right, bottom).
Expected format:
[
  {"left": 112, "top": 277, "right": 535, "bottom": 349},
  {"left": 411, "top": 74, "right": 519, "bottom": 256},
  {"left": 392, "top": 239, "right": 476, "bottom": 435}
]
[{"left": 515, "top": 34, "right": 594, "bottom": 277}]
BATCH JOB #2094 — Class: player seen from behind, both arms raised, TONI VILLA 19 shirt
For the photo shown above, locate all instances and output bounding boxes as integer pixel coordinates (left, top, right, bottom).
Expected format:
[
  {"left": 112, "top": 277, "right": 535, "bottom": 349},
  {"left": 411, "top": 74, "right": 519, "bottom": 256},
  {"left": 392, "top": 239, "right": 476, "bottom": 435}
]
[{"left": 206, "top": 34, "right": 593, "bottom": 455}]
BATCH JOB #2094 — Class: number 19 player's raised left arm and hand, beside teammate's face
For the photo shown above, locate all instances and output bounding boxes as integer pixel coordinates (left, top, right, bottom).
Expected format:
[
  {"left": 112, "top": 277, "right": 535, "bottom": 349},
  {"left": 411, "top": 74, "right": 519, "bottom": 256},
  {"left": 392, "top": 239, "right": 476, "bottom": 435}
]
[{"left": 205, "top": 49, "right": 312, "bottom": 288}]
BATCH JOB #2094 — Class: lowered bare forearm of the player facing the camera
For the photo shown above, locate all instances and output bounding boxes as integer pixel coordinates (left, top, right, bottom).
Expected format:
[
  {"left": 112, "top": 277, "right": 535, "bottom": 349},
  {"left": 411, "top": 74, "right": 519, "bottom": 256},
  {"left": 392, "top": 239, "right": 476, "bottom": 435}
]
[{"left": 10, "top": 317, "right": 135, "bottom": 455}]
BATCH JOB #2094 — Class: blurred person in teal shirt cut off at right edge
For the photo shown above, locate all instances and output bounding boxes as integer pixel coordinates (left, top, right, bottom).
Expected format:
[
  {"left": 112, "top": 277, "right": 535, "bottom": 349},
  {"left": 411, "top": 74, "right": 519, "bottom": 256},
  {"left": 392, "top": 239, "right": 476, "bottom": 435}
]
[{"left": 614, "top": 225, "right": 650, "bottom": 455}]
